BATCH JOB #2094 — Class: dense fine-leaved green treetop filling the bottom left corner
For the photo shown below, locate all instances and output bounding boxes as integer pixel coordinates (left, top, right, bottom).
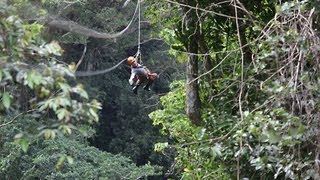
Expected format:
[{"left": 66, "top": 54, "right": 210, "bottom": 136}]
[{"left": 0, "top": 117, "right": 159, "bottom": 179}]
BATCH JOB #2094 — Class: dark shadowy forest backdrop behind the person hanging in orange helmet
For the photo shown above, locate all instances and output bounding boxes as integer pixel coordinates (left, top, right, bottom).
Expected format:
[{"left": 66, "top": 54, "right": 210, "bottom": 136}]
[{"left": 33, "top": 1, "right": 178, "bottom": 173}]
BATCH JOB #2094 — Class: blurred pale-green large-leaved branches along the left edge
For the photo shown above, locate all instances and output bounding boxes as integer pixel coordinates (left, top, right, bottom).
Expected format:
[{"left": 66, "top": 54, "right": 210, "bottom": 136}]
[{"left": 0, "top": 1, "right": 100, "bottom": 151}]
